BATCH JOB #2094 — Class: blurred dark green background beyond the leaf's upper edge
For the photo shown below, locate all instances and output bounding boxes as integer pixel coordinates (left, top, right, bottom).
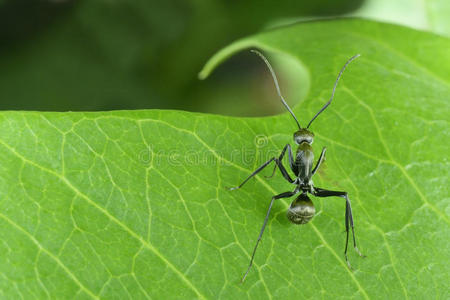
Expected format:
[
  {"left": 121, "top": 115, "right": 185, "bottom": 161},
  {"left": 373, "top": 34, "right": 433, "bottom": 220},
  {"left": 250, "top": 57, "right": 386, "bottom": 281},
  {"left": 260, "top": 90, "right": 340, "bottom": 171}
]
[{"left": 0, "top": 0, "right": 450, "bottom": 116}]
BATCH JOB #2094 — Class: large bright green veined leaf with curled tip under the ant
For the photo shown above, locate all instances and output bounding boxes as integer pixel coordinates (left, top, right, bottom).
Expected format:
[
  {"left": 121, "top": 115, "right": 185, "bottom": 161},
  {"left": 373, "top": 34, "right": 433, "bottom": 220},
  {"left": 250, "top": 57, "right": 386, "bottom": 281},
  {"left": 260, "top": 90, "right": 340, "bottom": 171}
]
[{"left": 0, "top": 20, "right": 450, "bottom": 299}]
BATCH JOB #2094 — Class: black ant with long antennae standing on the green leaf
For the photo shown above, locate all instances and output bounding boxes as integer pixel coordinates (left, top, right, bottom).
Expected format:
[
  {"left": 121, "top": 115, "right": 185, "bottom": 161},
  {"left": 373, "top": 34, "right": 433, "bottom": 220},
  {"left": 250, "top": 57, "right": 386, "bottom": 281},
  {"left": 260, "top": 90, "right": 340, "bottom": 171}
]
[{"left": 230, "top": 50, "right": 364, "bottom": 282}]
